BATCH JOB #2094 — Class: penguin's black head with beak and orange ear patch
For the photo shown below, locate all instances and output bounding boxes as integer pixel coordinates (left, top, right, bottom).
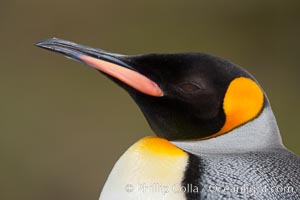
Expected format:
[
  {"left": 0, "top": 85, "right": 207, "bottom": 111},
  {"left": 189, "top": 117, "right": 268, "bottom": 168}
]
[{"left": 37, "top": 38, "right": 267, "bottom": 140}]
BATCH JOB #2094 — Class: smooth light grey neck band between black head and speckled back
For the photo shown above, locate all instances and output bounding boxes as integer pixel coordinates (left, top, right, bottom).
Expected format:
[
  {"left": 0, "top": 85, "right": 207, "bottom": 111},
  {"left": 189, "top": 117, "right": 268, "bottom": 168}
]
[{"left": 172, "top": 104, "right": 284, "bottom": 155}]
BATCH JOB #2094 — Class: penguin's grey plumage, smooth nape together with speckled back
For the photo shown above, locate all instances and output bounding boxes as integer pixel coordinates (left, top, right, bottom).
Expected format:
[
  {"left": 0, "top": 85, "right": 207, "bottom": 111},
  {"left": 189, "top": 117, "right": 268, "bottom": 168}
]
[{"left": 173, "top": 104, "right": 300, "bottom": 200}]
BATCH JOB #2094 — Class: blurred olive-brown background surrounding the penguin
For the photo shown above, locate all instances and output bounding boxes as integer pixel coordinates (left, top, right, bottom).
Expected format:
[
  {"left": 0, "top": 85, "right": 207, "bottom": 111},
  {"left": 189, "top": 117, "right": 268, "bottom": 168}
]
[{"left": 0, "top": 0, "right": 300, "bottom": 200}]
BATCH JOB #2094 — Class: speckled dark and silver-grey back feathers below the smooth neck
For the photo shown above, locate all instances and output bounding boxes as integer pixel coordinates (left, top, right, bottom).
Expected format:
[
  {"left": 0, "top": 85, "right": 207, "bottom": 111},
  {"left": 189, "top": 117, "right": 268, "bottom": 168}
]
[{"left": 192, "top": 149, "right": 300, "bottom": 200}]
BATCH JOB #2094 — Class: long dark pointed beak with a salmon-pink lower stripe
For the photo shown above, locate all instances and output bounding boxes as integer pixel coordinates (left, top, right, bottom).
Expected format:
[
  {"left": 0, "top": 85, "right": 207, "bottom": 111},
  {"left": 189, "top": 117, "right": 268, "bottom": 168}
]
[{"left": 36, "top": 38, "right": 163, "bottom": 97}]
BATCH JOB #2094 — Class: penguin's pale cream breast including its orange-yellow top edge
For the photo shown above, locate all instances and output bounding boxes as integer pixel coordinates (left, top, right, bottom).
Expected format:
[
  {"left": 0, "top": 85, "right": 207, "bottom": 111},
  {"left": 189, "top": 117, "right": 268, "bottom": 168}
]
[{"left": 100, "top": 137, "right": 189, "bottom": 200}]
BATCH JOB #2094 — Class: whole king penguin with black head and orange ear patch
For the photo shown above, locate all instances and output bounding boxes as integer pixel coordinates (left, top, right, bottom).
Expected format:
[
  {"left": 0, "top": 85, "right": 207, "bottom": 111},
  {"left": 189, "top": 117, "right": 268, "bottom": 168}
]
[{"left": 36, "top": 38, "right": 300, "bottom": 200}]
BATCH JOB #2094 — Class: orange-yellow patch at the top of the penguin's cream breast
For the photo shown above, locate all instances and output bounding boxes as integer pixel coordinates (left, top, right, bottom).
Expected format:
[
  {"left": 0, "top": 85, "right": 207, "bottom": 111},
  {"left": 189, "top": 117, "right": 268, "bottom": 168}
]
[{"left": 134, "top": 136, "right": 187, "bottom": 156}]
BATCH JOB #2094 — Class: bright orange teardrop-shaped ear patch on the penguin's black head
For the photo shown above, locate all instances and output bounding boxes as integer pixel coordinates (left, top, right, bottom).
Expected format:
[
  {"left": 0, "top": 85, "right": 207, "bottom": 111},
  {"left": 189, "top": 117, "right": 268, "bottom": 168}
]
[{"left": 210, "top": 77, "right": 264, "bottom": 137}]
